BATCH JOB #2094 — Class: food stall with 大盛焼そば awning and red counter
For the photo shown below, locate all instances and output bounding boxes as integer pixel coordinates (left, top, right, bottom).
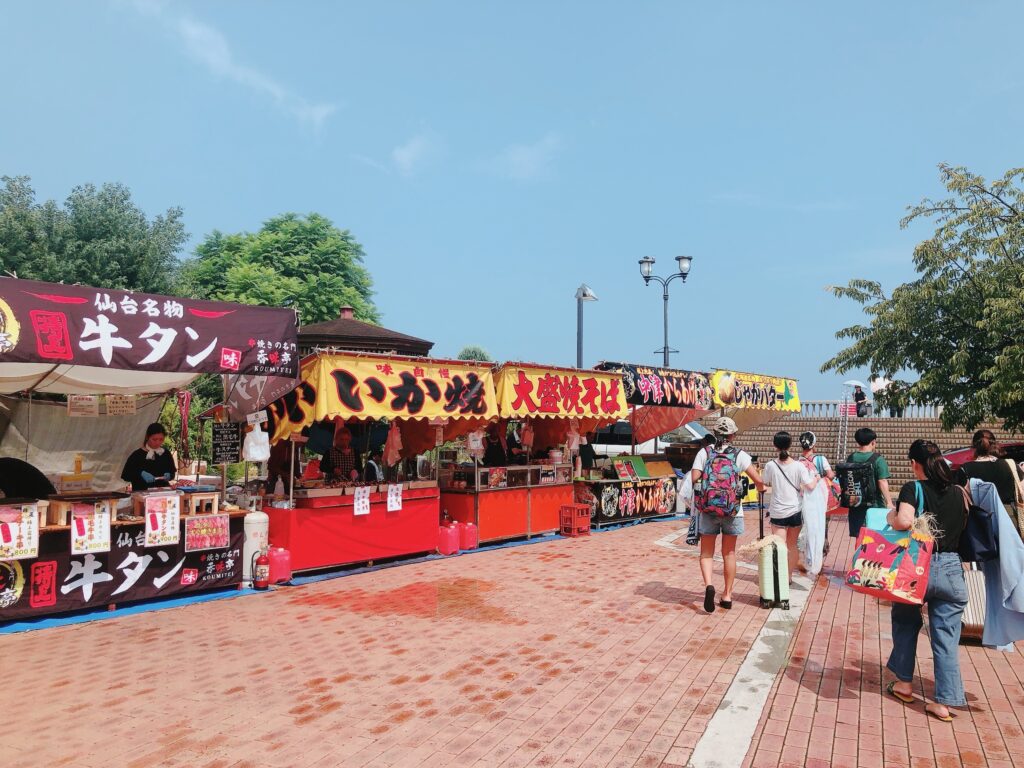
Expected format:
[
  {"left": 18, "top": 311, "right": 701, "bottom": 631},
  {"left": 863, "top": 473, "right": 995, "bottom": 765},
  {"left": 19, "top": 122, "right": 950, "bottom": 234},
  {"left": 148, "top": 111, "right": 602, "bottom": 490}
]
[{"left": 440, "top": 362, "right": 627, "bottom": 542}]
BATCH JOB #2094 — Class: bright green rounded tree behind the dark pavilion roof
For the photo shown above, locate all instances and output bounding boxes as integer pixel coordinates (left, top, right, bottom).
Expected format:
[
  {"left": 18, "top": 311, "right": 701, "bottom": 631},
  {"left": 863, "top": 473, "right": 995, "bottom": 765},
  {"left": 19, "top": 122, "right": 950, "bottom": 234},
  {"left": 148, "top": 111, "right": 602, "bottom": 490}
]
[{"left": 181, "top": 213, "right": 379, "bottom": 324}]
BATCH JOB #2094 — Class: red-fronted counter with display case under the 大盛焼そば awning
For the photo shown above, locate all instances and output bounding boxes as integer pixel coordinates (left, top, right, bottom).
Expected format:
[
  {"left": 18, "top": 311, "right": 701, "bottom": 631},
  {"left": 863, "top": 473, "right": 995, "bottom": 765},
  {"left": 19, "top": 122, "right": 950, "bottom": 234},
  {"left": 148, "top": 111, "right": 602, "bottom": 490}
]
[{"left": 438, "top": 463, "right": 572, "bottom": 542}]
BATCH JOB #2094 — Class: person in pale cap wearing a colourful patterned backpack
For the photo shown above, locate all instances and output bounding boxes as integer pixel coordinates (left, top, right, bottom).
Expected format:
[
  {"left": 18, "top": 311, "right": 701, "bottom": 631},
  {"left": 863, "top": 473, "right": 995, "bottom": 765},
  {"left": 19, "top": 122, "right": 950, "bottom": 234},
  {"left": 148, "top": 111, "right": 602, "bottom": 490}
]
[{"left": 690, "top": 416, "right": 764, "bottom": 613}]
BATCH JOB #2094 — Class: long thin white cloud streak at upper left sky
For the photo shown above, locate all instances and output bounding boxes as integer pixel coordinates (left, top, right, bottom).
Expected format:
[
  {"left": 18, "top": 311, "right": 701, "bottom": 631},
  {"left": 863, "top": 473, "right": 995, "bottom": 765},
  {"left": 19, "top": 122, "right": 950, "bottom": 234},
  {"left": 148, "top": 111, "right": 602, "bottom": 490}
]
[{"left": 124, "top": 0, "right": 338, "bottom": 130}]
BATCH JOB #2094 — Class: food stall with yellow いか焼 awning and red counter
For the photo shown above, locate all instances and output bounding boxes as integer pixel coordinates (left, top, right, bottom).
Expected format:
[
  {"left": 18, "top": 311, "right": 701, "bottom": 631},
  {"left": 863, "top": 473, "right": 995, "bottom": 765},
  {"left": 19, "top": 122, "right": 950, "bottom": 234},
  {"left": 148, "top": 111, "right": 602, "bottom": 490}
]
[{"left": 264, "top": 352, "right": 498, "bottom": 570}]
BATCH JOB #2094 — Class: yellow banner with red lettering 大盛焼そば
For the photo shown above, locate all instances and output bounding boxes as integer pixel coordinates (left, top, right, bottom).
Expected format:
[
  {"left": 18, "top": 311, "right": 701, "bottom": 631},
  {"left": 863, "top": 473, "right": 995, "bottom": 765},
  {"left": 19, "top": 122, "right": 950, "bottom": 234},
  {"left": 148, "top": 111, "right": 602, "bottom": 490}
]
[{"left": 495, "top": 365, "right": 629, "bottom": 421}]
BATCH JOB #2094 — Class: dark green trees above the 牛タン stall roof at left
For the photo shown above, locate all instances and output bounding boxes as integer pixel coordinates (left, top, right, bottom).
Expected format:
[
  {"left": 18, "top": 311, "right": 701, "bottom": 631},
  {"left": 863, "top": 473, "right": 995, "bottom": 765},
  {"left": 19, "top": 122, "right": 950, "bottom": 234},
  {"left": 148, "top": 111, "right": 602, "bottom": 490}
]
[{"left": 0, "top": 176, "right": 187, "bottom": 294}]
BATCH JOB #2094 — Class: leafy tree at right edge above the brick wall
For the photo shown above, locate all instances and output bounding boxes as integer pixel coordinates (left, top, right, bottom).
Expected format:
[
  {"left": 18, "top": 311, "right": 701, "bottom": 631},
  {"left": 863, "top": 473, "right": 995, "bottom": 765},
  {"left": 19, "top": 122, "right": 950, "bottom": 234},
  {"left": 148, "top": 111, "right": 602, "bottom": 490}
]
[{"left": 821, "top": 165, "right": 1024, "bottom": 430}]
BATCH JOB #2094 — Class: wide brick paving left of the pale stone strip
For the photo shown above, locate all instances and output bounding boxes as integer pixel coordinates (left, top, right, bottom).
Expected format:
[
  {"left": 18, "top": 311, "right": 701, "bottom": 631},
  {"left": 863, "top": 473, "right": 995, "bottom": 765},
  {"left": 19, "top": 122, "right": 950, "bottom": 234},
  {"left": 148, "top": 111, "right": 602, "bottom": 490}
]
[{"left": 6, "top": 517, "right": 774, "bottom": 768}]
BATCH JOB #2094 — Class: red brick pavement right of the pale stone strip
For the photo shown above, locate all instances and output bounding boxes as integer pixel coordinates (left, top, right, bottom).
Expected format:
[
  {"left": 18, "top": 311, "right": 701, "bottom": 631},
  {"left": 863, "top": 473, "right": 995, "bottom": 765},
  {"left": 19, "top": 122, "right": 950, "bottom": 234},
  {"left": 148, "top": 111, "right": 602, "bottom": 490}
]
[{"left": 744, "top": 519, "right": 1024, "bottom": 768}]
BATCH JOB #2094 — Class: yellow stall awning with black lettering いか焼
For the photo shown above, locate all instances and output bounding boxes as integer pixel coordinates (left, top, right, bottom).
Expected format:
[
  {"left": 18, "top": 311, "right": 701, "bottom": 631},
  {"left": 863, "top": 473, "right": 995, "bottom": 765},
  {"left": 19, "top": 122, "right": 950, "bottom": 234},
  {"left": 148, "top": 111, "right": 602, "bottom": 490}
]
[{"left": 267, "top": 353, "right": 498, "bottom": 440}]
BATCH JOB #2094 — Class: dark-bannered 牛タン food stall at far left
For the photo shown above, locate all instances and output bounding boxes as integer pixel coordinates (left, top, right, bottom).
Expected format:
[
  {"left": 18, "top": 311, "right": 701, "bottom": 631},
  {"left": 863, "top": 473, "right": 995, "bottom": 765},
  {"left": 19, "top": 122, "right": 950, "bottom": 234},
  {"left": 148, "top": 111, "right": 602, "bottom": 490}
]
[{"left": 0, "top": 279, "right": 297, "bottom": 622}]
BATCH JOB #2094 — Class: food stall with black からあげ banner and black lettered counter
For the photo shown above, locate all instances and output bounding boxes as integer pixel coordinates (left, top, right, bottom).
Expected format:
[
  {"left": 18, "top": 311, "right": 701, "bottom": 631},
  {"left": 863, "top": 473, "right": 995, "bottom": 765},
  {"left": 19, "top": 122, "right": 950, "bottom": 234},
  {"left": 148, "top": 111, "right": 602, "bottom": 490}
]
[{"left": 574, "top": 362, "right": 714, "bottom": 527}]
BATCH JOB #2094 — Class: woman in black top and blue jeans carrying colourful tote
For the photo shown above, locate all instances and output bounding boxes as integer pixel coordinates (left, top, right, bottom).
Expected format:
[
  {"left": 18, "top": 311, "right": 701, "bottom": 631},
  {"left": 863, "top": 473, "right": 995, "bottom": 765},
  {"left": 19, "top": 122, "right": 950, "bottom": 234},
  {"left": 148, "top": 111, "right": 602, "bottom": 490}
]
[{"left": 886, "top": 440, "right": 967, "bottom": 722}]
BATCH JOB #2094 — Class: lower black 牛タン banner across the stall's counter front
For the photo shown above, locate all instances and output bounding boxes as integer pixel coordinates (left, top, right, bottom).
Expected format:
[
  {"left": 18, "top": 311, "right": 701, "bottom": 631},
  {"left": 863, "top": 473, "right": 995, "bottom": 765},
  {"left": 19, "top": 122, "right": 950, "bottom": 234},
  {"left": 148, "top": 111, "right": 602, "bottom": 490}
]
[{"left": 0, "top": 517, "right": 245, "bottom": 623}]
